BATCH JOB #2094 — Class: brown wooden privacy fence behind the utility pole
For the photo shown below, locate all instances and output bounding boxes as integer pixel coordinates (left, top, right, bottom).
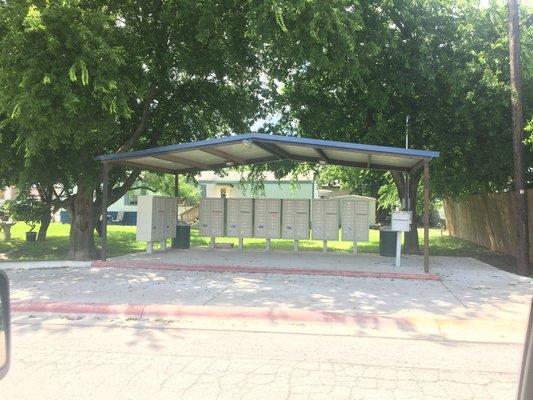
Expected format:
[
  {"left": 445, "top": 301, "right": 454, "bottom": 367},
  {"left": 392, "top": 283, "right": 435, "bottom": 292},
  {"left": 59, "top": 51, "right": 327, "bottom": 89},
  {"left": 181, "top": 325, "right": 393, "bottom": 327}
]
[{"left": 444, "top": 189, "right": 533, "bottom": 262}]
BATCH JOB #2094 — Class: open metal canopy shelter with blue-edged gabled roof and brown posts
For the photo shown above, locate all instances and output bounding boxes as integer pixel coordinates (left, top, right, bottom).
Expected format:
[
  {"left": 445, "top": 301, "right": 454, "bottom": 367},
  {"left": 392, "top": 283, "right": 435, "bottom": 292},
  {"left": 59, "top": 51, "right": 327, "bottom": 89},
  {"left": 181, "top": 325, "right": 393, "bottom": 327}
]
[{"left": 96, "top": 133, "right": 439, "bottom": 272}]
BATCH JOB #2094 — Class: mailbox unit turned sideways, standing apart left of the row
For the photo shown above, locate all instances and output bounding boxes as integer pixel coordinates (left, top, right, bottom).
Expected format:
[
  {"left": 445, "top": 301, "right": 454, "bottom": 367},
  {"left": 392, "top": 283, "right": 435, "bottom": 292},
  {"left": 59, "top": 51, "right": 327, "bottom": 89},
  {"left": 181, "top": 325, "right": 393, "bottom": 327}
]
[{"left": 137, "top": 196, "right": 178, "bottom": 253}]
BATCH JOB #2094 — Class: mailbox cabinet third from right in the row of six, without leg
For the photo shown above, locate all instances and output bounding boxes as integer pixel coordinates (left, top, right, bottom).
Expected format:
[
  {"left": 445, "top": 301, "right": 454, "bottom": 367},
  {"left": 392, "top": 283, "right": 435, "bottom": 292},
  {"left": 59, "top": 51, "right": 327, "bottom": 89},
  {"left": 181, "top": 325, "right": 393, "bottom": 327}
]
[{"left": 281, "top": 199, "right": 310, "bottom": 240}]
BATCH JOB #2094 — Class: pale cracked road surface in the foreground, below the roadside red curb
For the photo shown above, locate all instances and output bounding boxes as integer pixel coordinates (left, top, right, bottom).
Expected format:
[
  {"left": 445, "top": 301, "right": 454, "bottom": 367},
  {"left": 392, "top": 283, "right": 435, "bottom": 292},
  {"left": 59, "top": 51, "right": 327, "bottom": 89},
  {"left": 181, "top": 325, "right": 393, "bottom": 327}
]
[{"left": 0, "top": 316, "right": 521, "bottom": 400}]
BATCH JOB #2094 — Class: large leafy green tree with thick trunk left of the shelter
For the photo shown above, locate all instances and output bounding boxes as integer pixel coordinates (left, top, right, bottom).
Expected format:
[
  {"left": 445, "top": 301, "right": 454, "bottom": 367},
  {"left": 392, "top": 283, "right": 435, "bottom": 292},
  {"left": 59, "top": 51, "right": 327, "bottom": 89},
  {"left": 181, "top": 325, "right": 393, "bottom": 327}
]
[{"left": 0, "top": 0, "right": 260, "bottom": 259}]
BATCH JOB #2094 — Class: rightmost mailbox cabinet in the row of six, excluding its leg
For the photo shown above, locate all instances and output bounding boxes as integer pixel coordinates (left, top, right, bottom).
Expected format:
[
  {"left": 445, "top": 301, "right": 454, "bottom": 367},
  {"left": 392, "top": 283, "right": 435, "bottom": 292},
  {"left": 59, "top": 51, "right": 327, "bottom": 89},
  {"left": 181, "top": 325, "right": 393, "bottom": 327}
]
[{"left": 341, "top": 199, "right": 369, "bottom": 243}]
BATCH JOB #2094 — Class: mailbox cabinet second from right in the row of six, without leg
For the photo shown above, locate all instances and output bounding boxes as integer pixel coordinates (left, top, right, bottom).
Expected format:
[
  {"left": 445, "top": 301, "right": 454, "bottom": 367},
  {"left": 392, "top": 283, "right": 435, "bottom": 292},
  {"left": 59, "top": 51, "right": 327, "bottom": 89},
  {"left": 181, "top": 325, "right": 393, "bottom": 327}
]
[{"left": 311, "top": 199, "right": 339, "bottom": 241}]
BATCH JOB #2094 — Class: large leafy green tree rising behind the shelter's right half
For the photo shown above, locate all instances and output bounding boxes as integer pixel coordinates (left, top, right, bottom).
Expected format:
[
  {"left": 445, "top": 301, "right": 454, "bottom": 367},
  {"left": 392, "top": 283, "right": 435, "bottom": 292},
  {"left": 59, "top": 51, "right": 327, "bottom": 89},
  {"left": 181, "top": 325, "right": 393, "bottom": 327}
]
[{"left": 256, "top": 0, "right": 533, "bottom": 252}]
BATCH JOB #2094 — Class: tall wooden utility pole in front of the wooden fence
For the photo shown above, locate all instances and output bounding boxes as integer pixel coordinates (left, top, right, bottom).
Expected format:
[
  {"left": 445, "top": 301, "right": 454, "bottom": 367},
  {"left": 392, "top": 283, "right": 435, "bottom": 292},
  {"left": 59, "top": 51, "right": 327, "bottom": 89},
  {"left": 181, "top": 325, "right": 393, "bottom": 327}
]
[{"left": 508, "top": 0, "right": 529, "bottom": 275}]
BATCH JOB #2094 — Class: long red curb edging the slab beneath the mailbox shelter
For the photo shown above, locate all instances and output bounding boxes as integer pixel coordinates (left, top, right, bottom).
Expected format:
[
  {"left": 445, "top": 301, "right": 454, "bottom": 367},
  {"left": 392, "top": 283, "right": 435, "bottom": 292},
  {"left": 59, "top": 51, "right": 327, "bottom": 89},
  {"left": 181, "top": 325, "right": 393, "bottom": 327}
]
[{"left": 91, "top": 260, "right": 440, "bottom": 281}]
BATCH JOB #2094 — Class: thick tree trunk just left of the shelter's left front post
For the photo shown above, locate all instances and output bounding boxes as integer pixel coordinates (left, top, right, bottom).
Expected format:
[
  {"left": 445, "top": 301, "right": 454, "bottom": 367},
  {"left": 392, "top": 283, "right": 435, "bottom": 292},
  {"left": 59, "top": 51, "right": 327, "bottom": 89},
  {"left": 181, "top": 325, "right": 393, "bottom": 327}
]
[{"left": 69, "top": 182, "right": 98, "bottom": 260}]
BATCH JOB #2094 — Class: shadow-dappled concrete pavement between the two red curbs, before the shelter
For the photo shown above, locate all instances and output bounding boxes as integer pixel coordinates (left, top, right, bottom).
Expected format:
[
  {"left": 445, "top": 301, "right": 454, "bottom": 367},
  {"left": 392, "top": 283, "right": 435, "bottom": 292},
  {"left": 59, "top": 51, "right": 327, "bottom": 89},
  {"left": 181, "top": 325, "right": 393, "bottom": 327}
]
[{"left": 8, "top": 259, "right": 533, "bottom": 341}]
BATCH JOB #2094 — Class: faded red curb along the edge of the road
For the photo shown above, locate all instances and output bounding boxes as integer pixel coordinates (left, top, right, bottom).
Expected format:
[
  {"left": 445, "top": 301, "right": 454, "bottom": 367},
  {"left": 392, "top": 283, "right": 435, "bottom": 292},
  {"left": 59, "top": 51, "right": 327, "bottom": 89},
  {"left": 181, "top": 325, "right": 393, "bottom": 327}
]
[{"left": 11, "top": 302, "right": 415, "bottom": 331}]
